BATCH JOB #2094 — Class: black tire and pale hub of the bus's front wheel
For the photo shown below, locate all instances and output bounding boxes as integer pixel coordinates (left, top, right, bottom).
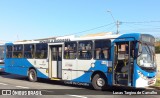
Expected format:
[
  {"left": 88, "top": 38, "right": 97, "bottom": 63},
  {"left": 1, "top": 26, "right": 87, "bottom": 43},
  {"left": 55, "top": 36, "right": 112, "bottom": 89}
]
[{"left": 92, "top": 74, "right": 107, "bottom": 90}]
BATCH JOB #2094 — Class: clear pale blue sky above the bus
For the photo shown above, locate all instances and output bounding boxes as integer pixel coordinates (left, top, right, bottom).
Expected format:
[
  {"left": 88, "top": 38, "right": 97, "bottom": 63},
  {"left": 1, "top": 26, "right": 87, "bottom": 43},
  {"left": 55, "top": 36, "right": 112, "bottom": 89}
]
[{"left": 0, "top": 0, "right": 160, "bottom": 41}]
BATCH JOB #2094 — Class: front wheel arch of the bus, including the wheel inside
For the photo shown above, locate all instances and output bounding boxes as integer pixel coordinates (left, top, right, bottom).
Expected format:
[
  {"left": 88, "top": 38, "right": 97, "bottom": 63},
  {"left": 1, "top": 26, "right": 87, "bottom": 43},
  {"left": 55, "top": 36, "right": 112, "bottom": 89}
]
[{"left": 91, "top": 71, "right": 108, "bottom": 90}]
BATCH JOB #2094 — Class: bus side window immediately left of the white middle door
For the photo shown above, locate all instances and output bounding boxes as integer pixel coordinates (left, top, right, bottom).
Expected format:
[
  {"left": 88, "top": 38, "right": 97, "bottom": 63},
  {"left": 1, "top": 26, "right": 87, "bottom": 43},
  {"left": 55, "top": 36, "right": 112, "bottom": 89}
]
[{"left": 35, "top": 43, "right": 48, "bottom": 59}]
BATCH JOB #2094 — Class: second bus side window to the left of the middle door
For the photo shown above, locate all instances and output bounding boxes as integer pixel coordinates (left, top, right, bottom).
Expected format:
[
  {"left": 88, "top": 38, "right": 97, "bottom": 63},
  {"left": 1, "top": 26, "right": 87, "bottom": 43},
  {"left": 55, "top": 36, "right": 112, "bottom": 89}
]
[{"left": 24, "top": 44, "right": 34, "bottom": 59}]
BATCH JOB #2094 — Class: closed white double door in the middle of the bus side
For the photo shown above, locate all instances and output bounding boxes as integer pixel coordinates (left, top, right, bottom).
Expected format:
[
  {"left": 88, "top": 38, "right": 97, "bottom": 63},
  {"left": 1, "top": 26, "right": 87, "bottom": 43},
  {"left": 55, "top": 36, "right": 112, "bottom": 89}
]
[{"left": 50, "top": 45, "right": 62, "bottom": 79}]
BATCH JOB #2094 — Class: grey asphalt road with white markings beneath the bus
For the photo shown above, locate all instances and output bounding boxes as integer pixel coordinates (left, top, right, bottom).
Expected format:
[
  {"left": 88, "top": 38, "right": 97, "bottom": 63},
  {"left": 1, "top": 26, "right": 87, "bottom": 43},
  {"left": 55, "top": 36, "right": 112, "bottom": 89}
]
[{"left": 0, "top": 73, "right": 160, "bottom": 98}]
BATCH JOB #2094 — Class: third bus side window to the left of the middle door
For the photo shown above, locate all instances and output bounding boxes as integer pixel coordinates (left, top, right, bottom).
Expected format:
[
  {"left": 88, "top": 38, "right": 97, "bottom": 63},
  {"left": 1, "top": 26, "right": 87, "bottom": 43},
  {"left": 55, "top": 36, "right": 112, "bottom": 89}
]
[{"left": 13, "top": 45, "right": 23, "bottom": 58}]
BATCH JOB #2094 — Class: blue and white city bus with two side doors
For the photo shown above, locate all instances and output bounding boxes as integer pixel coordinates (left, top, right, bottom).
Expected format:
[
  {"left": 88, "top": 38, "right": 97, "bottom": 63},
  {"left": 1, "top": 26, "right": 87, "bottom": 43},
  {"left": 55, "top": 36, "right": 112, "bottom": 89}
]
[{"left": 5, "top": 33, "right": 156, "bottom": 90}]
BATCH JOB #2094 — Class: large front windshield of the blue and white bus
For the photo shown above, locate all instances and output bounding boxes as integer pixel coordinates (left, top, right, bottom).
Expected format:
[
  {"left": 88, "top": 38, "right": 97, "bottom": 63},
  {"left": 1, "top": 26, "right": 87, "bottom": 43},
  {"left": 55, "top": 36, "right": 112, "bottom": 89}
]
[{"left": 137, "top": 42, "right": 156, "bottom": 71}]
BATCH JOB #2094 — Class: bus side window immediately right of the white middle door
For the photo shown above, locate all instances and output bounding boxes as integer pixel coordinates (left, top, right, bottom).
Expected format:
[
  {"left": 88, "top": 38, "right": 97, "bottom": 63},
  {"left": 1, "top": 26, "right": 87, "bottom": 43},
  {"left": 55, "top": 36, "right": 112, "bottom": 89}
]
[{"left": 64, "top": 42, "right": 77, "bottom": 59}]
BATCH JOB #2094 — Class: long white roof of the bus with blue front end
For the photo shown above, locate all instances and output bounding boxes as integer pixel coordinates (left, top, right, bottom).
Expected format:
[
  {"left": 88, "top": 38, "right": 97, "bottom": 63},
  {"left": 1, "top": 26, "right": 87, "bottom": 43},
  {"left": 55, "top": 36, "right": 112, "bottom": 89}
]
[{"left": 6, "top": 32, "right": 152, "bottom": 45}]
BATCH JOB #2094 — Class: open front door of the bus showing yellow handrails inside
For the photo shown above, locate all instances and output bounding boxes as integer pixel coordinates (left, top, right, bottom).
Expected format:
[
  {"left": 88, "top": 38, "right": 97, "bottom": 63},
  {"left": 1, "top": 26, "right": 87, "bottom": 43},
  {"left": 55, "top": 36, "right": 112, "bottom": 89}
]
[{"left": 113, "top": 41, "right": 133, "bottom": 86}]
